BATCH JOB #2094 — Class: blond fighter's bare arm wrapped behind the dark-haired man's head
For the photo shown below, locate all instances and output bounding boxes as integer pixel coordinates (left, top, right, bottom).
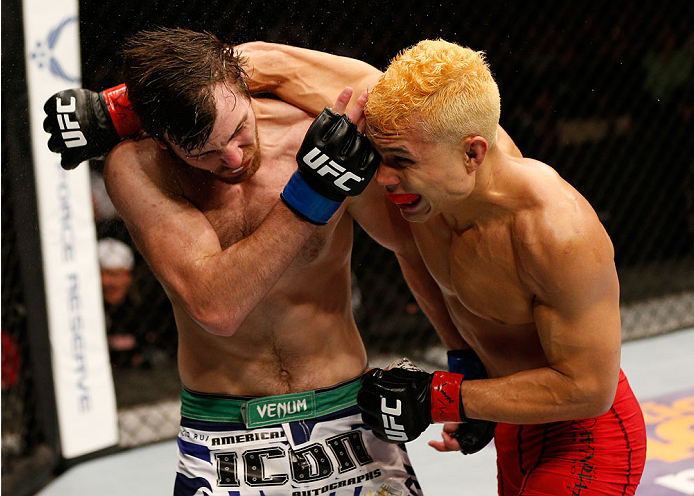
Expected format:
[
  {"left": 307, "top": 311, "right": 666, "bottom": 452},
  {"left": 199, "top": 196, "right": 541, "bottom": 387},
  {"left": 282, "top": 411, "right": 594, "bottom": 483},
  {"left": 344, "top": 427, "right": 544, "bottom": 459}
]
[{"left": 237, "top": 41, "right": 381, "bottom": 115}]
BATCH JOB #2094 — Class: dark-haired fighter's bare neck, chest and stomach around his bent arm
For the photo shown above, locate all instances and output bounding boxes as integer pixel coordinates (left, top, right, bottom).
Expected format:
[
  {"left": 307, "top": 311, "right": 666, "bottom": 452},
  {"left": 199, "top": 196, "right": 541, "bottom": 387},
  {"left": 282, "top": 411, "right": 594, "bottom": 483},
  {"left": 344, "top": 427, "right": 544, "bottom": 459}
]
[{"left": 115, "top": 99, "right": 366, "bottom": 396}]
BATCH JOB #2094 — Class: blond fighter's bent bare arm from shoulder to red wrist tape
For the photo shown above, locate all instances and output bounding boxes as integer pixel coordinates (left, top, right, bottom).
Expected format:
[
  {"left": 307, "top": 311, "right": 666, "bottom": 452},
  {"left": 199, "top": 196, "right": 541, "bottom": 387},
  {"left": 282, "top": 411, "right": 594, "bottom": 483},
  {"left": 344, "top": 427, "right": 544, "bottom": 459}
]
[{"left": 461, "top": 207, "right": 621, "bottom": 423}]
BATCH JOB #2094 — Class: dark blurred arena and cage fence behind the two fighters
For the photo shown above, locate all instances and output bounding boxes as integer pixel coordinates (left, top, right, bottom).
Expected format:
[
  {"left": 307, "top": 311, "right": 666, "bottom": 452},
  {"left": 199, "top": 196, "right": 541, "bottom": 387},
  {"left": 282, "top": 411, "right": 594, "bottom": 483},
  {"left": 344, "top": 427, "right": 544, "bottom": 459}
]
[{"left": 1, "top": 0, "right": 694, "bottom": 495}]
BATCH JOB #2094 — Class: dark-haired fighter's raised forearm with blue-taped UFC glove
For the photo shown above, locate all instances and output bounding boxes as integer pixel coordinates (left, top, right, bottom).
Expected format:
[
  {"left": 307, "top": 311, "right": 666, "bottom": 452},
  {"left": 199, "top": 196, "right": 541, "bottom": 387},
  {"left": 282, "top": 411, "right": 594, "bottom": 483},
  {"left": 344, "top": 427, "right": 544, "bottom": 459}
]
[{"left": 171, "top": 99, "right": 378, "bottom": 334}]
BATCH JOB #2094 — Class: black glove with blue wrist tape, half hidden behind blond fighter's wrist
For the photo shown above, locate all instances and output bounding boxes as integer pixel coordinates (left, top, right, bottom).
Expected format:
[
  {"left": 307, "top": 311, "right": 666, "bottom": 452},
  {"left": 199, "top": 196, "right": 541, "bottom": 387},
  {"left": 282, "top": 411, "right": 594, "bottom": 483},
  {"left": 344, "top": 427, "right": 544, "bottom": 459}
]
[{"left": 448, "top": 350, "right": 496, "bottom": 455}]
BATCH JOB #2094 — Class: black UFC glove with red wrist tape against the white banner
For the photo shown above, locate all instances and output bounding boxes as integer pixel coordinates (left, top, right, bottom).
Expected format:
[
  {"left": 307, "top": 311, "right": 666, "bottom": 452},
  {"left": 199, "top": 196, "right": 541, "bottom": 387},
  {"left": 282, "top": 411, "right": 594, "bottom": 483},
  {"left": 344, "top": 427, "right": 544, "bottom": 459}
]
[{"left": 43, "top": 84, "right": 140, "bottom": 170}]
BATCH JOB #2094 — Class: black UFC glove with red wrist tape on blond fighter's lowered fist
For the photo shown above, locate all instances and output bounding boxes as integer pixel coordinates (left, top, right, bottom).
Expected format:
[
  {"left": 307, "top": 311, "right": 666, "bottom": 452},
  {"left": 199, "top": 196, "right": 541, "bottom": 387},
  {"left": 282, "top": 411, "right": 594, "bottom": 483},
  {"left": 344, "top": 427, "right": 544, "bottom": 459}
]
[{"left": 357, "top": 358, "right": 465, "bottom": 443}]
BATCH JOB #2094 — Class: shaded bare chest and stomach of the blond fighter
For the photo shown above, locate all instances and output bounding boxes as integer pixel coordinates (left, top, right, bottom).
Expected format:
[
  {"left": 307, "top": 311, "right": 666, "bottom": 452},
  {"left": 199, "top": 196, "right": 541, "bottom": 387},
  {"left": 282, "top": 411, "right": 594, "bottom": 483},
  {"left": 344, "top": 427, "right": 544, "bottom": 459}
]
[{"left": 412, "top": 218, "right": 545, "bottom": 377}]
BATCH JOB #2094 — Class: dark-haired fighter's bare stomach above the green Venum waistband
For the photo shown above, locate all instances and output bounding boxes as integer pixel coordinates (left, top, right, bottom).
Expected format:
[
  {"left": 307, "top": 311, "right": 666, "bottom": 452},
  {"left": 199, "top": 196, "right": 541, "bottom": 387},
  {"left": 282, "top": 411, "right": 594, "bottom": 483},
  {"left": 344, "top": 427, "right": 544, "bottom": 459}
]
[{"left": 174, "top": 266, "right": 366, "bottom": 396}]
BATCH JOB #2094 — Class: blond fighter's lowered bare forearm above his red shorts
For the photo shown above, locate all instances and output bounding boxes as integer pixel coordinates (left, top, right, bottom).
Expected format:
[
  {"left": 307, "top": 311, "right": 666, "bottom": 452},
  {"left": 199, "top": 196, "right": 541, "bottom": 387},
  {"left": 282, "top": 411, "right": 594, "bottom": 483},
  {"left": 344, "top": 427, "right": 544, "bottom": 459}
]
[{"left": 460, "top": 367, "right": 616, "bottom": 424}]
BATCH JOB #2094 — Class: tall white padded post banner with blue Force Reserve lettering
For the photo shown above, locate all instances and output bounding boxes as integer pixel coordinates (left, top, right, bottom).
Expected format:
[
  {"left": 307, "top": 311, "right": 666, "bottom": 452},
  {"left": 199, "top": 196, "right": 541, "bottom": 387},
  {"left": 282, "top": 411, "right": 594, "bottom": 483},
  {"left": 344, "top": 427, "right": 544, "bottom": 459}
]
[{"left": 23, "top": 0, "right": 118, "bottom": 459}]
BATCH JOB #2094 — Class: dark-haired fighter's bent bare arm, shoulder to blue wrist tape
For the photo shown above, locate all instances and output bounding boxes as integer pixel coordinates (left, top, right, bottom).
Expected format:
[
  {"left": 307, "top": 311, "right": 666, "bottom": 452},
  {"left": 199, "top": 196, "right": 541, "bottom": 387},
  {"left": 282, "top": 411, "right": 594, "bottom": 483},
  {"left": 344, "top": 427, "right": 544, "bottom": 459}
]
[{"left": 104, "top": 140, "right": 315, "bottom": 336}]
